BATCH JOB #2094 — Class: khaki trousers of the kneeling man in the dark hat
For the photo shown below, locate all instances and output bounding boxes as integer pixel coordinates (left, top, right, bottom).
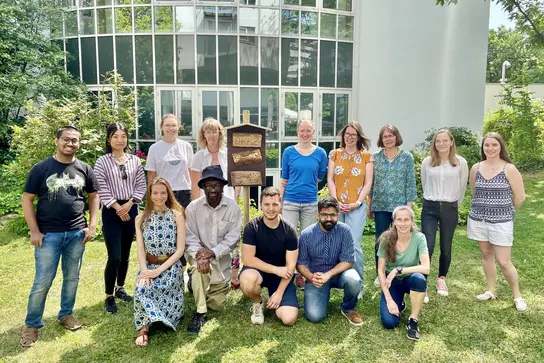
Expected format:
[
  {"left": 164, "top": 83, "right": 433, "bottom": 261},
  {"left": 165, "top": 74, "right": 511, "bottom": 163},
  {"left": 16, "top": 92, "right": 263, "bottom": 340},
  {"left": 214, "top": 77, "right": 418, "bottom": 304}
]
[{"left": 191, "top": 268, "right": 230, "bottom": 314}]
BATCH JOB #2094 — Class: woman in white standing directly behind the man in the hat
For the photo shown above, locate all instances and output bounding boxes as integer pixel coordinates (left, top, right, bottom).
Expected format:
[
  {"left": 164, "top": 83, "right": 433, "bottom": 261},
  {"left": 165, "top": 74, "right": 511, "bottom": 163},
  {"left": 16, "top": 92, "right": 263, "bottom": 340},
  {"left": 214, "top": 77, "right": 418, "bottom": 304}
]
[{"left": 191, "top": 117, "right": 240, "bottom": 289}]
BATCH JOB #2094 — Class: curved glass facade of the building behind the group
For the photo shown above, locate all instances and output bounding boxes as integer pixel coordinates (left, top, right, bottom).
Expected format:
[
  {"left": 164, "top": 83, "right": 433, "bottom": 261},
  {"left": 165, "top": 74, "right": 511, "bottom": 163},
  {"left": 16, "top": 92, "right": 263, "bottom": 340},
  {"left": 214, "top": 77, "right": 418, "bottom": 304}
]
[{"left": 58, "top": 0, "right": 356, "bottom": 192}]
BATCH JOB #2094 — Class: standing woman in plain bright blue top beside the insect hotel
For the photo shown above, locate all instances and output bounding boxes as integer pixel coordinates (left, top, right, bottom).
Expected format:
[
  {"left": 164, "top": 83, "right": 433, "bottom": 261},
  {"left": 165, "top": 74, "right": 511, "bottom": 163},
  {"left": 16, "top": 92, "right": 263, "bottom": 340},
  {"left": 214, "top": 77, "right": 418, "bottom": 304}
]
[{"left": 280, "top": 120, "right": 328, "bottom": 239}]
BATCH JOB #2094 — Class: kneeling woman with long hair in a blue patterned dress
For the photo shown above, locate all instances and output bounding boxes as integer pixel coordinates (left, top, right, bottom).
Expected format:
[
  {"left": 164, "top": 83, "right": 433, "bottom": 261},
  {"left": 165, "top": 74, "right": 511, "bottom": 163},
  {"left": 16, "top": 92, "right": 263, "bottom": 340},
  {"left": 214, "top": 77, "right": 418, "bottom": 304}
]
[{"left": 134, "top": 178, "right": 185, "bottom": 347}]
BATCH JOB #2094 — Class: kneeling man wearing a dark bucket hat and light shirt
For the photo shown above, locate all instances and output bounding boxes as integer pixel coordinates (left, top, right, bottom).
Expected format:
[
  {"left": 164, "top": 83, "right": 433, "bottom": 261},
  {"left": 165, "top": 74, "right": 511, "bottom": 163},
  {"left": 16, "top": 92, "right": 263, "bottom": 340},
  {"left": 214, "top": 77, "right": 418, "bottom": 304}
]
[{"left": 185, "top": 165, "right": 242, "bottom": 334}]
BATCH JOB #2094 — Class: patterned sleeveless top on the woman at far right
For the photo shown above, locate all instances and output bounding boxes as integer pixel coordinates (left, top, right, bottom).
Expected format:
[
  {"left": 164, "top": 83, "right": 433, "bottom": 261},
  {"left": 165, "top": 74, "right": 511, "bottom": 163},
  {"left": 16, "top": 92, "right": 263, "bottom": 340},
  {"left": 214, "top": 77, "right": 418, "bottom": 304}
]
[{"left": 468, "top": 163, "right": 515, "bottom": 223}]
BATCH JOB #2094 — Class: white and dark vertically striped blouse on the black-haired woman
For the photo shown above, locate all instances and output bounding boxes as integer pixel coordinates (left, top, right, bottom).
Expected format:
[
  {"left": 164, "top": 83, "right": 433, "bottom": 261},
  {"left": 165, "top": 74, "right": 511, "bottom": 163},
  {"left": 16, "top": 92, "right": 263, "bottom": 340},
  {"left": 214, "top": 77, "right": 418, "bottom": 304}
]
[{"left": 94, "top": 153, "right": 146, "bottom": 208}]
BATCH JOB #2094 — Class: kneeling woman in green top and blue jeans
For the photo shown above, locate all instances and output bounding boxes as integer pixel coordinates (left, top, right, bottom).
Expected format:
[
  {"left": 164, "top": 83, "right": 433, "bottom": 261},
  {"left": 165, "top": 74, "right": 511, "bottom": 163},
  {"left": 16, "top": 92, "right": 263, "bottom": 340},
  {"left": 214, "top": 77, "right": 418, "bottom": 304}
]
[{"left": 378, "top": 205, "right": 430, "bottom": 340}]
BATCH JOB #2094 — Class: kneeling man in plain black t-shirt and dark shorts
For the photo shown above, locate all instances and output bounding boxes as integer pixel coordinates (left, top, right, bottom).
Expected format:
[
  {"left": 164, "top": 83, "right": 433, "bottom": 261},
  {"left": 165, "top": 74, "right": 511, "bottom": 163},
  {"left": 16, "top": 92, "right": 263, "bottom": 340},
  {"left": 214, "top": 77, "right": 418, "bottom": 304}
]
[{"left": 240, "top": 187, "right": 299, "bottom": 326}]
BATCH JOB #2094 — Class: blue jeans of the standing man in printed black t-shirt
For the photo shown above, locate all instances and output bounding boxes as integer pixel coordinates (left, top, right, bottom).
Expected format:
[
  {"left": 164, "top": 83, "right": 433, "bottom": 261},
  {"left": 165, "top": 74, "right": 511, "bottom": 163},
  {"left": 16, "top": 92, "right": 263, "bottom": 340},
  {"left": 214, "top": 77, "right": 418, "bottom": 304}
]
[{"left": 25, "top": 229, "right": 85, "bottom": 328}]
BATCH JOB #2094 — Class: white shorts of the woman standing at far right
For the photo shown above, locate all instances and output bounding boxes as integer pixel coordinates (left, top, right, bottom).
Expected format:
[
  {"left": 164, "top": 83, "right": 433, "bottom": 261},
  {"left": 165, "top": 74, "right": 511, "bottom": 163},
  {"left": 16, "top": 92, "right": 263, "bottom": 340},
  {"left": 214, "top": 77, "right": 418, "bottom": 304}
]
[{"left": 467, "top": 218, "right": 514, "bottom": 247}]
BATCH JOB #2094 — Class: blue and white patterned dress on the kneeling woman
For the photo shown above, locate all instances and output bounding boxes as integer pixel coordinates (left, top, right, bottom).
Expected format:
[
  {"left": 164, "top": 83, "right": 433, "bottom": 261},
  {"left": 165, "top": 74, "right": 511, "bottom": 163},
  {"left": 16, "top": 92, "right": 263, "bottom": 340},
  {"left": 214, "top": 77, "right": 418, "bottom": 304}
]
[{"left": 134, "top": 209, "right": 184, "bottom": 330}]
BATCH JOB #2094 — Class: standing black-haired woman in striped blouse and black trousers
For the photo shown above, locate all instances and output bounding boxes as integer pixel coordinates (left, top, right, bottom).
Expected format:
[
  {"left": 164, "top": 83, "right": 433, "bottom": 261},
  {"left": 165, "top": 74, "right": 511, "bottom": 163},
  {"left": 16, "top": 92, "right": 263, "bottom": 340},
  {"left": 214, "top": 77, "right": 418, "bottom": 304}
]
[{"left": 94, "top": 123, "right": 146, "bottom": 314}]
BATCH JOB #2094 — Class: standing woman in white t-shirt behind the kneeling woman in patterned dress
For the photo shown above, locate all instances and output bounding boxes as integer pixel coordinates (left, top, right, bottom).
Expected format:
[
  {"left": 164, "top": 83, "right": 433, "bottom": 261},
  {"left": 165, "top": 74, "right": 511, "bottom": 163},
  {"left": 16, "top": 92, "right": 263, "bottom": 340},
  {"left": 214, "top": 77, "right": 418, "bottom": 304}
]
[{"left": 145, "top": 114, "right": 193, "bottom": 208}]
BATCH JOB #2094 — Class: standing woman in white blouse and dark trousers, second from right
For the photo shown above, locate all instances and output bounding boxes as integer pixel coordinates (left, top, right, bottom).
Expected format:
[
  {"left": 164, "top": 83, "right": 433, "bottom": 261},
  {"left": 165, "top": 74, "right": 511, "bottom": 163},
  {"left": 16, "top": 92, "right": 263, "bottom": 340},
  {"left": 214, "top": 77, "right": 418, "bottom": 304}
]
[{"left": 421, "top": 129, "right": 468, "bottom": 302}]
